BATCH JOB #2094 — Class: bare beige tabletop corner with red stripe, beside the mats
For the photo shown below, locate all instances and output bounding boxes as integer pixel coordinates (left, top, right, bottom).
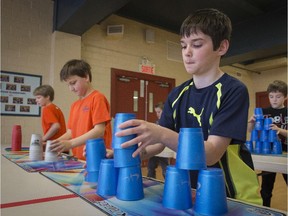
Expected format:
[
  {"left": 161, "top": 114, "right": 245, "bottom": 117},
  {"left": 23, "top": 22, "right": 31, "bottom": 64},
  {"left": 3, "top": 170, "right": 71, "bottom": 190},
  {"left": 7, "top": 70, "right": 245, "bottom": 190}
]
[{"left": 0, "top": 146, "right": 106, "bottom": 216}]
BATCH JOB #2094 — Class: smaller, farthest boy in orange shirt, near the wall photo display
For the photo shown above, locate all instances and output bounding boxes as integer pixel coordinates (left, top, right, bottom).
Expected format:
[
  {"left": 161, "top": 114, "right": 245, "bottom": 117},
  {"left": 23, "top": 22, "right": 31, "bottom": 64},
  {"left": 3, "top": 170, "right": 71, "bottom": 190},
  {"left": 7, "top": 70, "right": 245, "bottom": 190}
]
[{"left": 33, "top": 85, "right": 66, "bottom": 142}]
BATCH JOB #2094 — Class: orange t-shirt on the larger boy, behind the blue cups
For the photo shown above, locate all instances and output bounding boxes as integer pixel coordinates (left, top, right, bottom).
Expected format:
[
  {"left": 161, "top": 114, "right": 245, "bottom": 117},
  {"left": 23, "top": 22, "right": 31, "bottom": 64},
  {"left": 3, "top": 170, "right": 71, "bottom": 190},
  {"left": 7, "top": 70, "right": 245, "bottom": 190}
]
[{"left": 68, "top": 90, "right": 112, "bottom": 160}]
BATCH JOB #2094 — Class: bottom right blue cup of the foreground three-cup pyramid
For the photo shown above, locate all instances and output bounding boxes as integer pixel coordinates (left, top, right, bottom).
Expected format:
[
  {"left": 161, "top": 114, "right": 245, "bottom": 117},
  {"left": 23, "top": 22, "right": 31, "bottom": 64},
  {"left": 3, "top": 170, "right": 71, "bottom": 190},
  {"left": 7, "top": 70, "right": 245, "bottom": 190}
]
[{"left": 194, "top": 168, "right": 228, "bottom": 215}]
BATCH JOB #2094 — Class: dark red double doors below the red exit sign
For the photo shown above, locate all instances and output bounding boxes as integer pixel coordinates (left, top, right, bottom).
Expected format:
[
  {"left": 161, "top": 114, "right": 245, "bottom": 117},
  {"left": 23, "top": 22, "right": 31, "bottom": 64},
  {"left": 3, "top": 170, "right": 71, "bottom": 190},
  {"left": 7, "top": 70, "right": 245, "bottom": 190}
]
[{"left": 111, "top": 68, "right": 175, "bottom": 122}]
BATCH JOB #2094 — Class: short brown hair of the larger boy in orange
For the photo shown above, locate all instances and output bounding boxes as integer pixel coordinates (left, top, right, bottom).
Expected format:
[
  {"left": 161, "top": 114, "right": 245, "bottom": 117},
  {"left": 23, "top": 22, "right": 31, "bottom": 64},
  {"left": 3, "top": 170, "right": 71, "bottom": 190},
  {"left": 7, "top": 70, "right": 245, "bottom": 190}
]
[{"left": 60, "top": 59, "right": 92, "bottom": 82}]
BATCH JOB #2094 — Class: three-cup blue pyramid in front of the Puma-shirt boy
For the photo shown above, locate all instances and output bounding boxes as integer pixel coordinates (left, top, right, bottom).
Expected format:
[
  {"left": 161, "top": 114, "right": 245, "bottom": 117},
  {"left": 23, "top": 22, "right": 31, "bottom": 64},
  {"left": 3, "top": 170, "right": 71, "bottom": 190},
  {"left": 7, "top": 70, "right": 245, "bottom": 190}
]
[{"left": 162, "top": 128, "right": 228, "bottom": 215}]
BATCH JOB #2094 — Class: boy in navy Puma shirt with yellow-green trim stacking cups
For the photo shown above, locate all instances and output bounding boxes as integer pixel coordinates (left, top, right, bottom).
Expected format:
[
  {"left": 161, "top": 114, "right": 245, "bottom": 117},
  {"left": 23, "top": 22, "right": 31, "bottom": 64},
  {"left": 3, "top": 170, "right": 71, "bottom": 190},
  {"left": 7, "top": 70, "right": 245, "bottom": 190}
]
[{"left": 116, "top": 9, "right": 262, "bottom": 205}]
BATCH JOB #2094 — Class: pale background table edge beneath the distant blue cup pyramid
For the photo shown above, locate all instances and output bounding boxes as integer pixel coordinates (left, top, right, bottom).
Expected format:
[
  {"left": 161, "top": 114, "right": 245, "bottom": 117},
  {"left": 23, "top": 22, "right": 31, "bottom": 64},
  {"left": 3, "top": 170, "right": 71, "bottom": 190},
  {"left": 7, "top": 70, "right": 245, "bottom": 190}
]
[{"left": 252, "top": 154, "right": 288, "bottom": 174}]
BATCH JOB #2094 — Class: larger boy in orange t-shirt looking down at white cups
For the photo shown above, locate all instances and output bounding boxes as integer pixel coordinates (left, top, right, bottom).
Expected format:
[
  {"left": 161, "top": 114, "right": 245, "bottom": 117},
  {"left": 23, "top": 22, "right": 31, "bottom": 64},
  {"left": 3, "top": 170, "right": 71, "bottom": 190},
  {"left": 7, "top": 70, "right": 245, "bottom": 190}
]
[{"left": 51, "top": 59, "right": 112, "bottom": 160}]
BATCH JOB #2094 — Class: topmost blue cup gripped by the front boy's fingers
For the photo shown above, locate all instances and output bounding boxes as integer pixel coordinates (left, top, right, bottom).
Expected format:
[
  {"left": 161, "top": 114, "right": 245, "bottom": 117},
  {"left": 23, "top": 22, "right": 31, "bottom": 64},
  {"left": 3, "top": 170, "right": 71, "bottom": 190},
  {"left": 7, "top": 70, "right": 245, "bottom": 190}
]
[{"left": 112, "top": 113, "right": 137, "bottom": 149}]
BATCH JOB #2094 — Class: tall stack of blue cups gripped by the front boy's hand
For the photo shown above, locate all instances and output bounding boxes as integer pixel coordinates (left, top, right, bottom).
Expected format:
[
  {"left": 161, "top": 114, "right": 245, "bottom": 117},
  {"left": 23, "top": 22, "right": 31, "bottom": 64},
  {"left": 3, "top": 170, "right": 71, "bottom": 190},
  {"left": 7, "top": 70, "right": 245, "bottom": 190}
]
[{"left": 112, "top": 113, "right": 144, "bottom": 201}]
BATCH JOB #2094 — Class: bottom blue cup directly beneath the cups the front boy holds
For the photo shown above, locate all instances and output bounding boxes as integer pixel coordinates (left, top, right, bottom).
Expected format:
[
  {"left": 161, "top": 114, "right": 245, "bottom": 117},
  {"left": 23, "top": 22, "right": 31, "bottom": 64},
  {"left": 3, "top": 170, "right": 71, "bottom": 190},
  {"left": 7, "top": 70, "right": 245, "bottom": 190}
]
[{"left": 116, "top": 166, "right": 144, "bottom": 201}]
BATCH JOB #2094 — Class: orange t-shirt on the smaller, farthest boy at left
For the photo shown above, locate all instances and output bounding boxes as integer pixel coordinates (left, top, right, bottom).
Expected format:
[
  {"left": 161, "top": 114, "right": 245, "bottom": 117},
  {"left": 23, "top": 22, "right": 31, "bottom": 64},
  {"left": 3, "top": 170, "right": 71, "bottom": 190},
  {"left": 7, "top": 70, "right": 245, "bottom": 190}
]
[{"left": 41, "top": 103, "right": 66, "bottom": 140}]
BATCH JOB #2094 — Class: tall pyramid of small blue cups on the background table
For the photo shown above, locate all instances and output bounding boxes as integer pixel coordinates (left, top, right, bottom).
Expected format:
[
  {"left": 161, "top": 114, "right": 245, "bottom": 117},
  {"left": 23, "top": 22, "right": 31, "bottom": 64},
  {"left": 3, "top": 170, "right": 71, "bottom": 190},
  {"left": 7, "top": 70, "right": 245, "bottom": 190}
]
[{"left": 246, "top": 108, "right": 282, "bottom": 154}]
